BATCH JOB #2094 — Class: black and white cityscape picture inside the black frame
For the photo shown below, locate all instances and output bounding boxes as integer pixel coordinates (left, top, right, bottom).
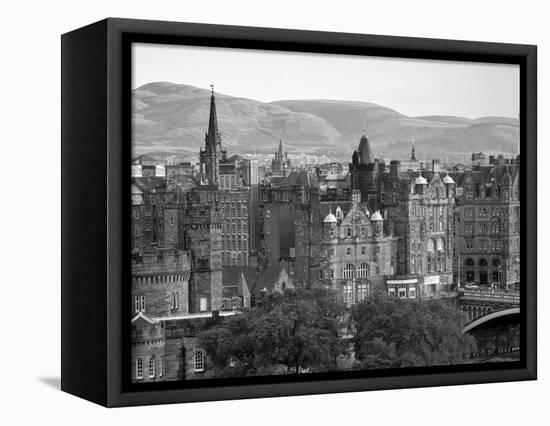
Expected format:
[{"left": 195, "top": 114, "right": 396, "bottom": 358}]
[{"left": 133, "top": 43, "right": 522, "bottom": 384}]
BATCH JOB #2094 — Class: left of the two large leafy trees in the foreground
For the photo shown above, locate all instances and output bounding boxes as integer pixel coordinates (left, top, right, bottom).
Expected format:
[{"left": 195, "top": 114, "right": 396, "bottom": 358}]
[{"left": 199, "top": 289, "right": 345, "bottom": 376}]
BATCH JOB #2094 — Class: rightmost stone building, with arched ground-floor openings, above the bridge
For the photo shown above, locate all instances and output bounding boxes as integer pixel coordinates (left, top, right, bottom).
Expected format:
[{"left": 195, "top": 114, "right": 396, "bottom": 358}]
[{"left": 453, "top": 153, "right": 520, "bottom": 288}]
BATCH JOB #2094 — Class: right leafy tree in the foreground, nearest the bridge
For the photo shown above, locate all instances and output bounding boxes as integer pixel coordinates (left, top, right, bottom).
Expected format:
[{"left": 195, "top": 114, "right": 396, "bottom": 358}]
[{"left": 351, "top": 293, "right": 476, "bottom": 368}]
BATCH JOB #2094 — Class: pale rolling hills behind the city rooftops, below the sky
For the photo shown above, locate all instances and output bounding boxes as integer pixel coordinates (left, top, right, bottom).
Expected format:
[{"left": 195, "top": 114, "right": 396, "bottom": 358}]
[{"left": 133, "top": 82, "right": 519, "bottom": 159}]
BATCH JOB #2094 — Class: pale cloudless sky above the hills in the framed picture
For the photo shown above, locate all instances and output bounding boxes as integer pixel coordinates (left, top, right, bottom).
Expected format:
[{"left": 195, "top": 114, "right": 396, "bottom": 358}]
[{"left": 132, "top": 44, "right": 519, "bottom": 118}]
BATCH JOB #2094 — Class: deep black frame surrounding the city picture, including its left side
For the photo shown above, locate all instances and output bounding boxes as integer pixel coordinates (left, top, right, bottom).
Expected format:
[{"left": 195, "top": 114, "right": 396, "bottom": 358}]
[{"left": 61, "top": 18, "right": 537, "bottom": 407}]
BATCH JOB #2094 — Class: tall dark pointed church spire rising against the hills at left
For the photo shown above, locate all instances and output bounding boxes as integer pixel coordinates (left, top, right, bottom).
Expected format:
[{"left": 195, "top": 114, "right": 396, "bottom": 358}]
[{"left": 200, "top": 84, "right": 226, "bottom": 185}]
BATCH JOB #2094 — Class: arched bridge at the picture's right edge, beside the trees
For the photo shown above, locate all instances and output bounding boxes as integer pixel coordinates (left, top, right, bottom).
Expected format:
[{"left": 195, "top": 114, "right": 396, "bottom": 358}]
[{"left": 458, "top": 289, "right": 520, "bottom": 333}]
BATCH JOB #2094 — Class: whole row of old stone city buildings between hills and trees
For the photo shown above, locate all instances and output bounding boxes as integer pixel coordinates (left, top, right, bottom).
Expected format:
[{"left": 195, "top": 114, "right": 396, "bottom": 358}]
[{"left": 131, "top": 86, "right": 520, "bottom": 382}]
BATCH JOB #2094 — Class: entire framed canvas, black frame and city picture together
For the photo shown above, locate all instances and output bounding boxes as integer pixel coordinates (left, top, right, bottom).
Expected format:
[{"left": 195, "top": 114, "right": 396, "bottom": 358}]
[{"left": 61, "top": 18, "right": 537, "bottom": 407}]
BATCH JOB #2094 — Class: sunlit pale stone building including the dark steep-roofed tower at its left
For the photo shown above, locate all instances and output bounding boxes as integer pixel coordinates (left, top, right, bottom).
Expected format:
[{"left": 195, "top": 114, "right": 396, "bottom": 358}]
[{"left": 350, "top": 137, "right": 455, "bottom": 295}]
